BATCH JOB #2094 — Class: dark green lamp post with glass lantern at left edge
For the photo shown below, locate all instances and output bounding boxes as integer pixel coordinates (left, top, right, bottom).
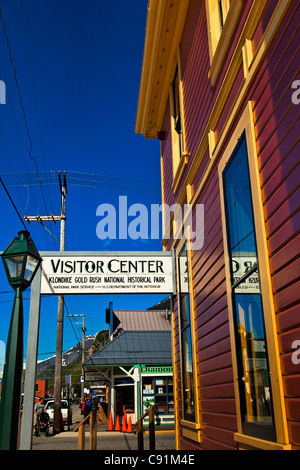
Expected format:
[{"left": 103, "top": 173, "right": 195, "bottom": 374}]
[{"left": 0, "top": 230, "right": 42, "bottom": 450}]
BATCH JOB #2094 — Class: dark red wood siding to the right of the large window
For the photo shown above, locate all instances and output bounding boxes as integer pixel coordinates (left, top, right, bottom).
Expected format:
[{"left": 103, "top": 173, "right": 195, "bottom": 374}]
[{"left": 252, "top": 2, "right": 300, "bottom": 449}]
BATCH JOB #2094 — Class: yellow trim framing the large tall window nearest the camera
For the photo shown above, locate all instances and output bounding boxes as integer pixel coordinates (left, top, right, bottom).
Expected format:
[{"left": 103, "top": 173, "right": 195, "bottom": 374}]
[{"left": 218, "top": 101, "right": 289, "bottom": 445}]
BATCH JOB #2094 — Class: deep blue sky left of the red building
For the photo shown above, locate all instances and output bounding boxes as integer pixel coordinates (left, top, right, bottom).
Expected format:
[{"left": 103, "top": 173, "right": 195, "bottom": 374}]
[{"left": 0, "top": 0, "right": 166, "bottom": 362}]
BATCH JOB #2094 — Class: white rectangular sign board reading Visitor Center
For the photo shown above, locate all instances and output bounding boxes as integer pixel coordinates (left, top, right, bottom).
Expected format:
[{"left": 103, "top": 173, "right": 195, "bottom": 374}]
[{"left": 41, "top": 252, "right": 173, "bottom": 295}]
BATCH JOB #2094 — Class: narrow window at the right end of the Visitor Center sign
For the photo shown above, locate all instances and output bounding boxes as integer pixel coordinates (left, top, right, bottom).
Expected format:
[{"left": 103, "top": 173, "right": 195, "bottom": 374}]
[{"left": 178, "top": 246, "right": 195, "bottom": 422}]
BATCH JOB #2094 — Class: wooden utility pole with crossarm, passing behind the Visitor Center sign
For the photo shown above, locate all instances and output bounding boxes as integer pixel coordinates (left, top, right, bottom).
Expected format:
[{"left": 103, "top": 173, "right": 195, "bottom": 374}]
[{"left": 24, "top": 171, "right": 67, "bottom": 434}]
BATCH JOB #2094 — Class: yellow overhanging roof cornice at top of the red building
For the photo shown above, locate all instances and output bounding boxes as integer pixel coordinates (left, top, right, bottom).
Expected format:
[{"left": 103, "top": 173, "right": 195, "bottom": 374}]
[{"left": 135, "top": 0, "right": 189, "bottom": 138}]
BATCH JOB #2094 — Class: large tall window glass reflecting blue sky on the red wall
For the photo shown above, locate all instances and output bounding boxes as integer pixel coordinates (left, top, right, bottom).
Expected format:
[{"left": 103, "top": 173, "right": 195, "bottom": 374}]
[{"left": 222, "top": 132, "right": 276, "bottom": 441}]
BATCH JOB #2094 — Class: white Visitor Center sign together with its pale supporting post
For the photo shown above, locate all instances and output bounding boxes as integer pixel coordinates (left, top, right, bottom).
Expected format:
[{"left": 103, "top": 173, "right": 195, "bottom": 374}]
[{"left": 20, "top": 251, "right": 176, "bottom": 450}]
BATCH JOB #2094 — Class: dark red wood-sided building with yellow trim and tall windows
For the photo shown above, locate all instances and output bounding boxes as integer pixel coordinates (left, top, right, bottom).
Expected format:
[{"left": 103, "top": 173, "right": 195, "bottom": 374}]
[{"left": 135, "top": 0, "right": 300, "bottom": 450}]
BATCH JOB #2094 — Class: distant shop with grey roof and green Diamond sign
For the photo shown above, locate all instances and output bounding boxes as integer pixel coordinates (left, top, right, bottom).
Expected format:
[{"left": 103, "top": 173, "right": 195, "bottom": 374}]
[{"left": 84, "top": 308, "right": 174, "bottom": 425}]
